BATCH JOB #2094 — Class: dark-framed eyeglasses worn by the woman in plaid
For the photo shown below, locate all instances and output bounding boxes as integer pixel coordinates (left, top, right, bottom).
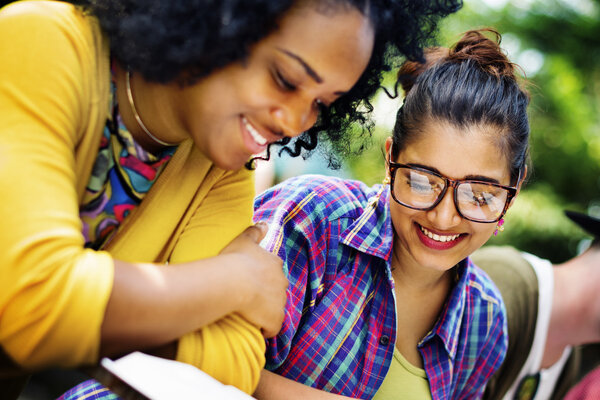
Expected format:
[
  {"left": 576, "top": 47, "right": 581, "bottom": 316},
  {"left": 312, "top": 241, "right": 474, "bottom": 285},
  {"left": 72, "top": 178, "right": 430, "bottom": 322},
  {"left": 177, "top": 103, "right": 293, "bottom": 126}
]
[{"left": 389, "top": 162, "right": 517, "bottom": 223}]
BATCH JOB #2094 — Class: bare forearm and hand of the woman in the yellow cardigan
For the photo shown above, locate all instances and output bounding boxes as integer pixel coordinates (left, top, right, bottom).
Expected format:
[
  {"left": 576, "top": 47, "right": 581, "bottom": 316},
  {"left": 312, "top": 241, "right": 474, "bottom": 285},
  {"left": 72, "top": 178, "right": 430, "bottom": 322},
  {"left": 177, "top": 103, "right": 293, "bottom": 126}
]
[{"left": 102, "top": 227, "right": 286, "bottom": 355}]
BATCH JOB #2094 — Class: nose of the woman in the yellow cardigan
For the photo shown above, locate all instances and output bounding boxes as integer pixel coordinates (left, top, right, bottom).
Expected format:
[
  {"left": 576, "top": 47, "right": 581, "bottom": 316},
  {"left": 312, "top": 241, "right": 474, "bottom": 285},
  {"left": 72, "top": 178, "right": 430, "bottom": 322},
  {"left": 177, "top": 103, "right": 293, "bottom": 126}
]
[{"left": 271, "top": 97, "right": 319, "bottom": 137}]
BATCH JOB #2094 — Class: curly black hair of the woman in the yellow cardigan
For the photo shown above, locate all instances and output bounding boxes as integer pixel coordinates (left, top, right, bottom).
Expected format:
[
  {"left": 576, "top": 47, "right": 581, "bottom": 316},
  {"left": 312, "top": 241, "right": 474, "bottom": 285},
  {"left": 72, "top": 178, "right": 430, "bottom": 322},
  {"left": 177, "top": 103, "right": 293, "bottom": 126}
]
[{"left": 71, "top": 0, "right": 462, "bottom": 166}]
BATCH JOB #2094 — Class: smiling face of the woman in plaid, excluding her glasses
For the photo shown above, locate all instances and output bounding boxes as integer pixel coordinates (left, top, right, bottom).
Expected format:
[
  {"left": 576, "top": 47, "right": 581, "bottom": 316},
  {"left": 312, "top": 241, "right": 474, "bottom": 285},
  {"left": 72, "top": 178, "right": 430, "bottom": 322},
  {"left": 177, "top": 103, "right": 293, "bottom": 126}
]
[{"left": 386, "top": 121, "right": 510, "bottom": 272}]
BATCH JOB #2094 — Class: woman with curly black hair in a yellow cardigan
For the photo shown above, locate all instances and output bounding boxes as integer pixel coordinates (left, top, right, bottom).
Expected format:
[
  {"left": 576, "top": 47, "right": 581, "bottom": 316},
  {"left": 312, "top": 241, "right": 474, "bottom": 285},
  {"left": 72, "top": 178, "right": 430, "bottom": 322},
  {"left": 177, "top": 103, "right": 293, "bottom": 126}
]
[{"left": 0, "top": 0, "right": 460, "bottom": 392}]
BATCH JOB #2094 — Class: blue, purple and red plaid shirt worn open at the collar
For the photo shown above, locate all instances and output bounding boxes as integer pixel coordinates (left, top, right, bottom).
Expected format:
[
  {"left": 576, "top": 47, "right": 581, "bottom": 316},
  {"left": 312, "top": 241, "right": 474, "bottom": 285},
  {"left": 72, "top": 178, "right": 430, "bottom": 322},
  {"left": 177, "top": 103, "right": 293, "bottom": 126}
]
[{"left": 254, "top": 175, "right": 507, "bottom": 400}]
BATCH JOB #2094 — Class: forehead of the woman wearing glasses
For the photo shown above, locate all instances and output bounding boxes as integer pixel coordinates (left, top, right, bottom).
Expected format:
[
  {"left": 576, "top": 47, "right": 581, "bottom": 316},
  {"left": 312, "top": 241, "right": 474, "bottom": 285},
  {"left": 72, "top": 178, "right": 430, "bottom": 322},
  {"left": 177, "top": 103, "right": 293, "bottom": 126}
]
[{"left": 399, "top": 121, "right": 510, "bottom": 185}]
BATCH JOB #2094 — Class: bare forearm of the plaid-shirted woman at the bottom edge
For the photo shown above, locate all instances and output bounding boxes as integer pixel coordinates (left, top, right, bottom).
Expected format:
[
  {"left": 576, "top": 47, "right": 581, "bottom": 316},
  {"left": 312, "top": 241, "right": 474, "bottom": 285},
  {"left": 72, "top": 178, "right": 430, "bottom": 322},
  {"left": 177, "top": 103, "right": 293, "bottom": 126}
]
[{"left": 254, "top": 370, "right": 350, "bottom": 400}]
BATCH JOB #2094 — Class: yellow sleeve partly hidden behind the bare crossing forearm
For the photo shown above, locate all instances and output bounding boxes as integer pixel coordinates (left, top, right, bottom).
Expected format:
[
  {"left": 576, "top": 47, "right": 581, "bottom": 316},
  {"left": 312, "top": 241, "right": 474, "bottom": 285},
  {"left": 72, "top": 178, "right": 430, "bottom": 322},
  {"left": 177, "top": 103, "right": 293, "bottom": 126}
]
[{"left": 170, "top": 169, "right": 265, "bottom": 393}]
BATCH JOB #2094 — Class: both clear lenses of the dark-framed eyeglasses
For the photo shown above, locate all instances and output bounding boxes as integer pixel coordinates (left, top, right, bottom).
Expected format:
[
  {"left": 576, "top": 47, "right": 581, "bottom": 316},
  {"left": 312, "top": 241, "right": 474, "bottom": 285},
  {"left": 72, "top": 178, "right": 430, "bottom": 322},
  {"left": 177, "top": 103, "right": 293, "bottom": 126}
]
[{"left": 393, "top": 167, "right": 508, "bottom": 222}]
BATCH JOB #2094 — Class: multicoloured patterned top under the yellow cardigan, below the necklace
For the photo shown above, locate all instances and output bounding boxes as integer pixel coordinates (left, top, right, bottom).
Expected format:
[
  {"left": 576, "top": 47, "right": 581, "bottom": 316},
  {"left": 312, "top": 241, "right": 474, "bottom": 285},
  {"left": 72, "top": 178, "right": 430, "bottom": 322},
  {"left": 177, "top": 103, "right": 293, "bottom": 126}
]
[{"left": 79, "top": 84, "right": 176, "bottom": 250}]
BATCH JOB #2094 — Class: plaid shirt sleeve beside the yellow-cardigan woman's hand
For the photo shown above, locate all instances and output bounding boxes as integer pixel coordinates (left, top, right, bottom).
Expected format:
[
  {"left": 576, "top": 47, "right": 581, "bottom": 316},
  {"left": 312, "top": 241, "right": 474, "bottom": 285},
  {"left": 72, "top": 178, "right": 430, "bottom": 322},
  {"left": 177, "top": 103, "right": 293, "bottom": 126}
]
[{"left": 254, "top": 181, "right": 330, "bottom": 370}]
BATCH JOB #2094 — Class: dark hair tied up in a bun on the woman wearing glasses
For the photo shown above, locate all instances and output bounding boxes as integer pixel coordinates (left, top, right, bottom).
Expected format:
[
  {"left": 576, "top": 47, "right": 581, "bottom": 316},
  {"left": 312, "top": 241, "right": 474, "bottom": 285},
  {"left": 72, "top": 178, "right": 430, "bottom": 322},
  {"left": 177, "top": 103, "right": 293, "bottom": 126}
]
[{"left": 392, "top": 29, "right": 529, "bottom": 184}]
